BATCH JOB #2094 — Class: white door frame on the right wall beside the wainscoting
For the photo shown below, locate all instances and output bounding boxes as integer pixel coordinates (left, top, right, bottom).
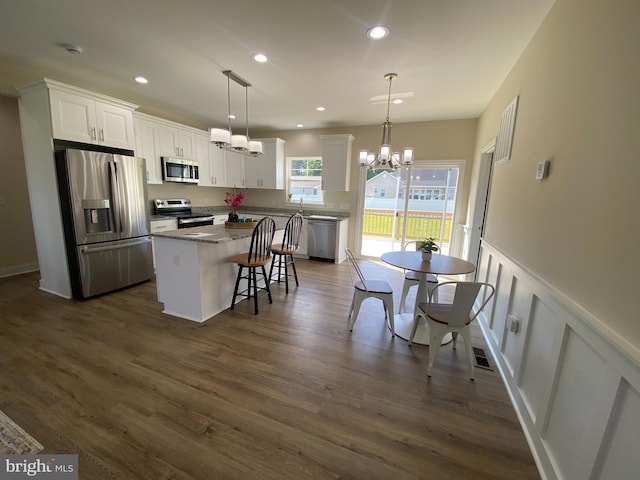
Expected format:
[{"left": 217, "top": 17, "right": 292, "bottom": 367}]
[{"left": 467, "top": 138, "right": 496, "bottom": 266}]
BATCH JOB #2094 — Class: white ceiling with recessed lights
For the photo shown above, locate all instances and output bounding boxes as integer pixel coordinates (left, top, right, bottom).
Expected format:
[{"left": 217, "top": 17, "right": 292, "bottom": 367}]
[{"left": 0, "top": 0, "right": 553, "bottom": 130}]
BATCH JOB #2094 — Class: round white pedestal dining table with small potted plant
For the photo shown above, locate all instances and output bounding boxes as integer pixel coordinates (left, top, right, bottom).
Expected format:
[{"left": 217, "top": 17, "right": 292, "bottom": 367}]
[{"left": 380, "top": 252, "right": 476, "bottom": 345}]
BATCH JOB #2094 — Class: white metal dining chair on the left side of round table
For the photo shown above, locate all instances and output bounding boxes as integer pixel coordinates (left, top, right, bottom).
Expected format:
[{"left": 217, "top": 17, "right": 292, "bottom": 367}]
[{"left": 345, "top": 248, "right": 396, "bottom": 338}]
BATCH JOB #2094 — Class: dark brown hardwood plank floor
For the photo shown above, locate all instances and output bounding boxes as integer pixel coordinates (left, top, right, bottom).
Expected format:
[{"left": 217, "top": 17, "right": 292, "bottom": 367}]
[{"left": 0, "top": 260, "right": 540, "bottom": 480}]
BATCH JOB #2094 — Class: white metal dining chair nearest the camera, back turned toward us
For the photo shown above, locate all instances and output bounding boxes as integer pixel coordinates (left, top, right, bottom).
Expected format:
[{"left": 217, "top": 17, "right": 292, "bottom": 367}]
[{"left": 409, "top": 282, "right": 495, "bottom": 380}]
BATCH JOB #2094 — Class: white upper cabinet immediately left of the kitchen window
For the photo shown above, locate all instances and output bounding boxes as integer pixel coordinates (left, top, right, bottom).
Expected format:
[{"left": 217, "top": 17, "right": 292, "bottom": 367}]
[{"left": 244, "top": 138, "right": 285, "bottom": 190}]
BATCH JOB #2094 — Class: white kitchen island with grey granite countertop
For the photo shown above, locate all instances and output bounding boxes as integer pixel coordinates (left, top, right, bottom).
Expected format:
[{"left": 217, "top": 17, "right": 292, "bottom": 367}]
[{"left": 152, "top": 225, "right": 282, "bottom": 322}]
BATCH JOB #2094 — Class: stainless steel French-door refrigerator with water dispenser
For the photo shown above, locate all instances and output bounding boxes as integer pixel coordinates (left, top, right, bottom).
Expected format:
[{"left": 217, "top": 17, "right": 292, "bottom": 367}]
[{"left": 56, "top": 149, "right": 153, "bottom": 298}]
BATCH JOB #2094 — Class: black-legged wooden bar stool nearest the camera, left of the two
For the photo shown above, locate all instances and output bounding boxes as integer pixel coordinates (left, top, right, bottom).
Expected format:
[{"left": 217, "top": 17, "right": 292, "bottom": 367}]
[{"left": 229, "top": 217, "right": 276, "bottom": 315}]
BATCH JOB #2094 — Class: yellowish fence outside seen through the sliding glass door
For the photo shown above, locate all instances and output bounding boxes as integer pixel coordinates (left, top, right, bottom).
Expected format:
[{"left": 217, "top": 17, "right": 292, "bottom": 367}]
[{"left": 362, "top": 208, "right": 453, "bottom": 243}]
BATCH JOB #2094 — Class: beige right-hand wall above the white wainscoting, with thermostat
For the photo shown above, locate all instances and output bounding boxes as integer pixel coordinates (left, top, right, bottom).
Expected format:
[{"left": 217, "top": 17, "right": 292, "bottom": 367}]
[{"left": 474, "top": 0, "right": 640, "bottom": 349}]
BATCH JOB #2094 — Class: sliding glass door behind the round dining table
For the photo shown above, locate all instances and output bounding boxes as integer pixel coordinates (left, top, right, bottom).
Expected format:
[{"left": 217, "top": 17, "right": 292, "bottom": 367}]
[{"left": 360, "top": 162, "right": 460, "bottom": 257}]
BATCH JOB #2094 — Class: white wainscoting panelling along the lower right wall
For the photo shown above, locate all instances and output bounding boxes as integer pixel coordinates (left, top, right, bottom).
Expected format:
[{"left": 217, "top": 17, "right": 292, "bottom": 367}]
[{"left": 477, "top": 241, "right": 640, "bottom": 480}]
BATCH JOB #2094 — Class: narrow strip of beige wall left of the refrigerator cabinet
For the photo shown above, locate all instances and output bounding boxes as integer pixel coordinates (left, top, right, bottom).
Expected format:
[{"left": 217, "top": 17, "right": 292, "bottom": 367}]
[{"left": 0, "top": 95, "right": 38, "bottom": 276}]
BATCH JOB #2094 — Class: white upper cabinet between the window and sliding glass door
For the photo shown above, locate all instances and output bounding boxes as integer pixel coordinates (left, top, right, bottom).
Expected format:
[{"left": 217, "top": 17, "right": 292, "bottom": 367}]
[{"left": 320, "top": 134, "right": 355, "bottom": 192}]
